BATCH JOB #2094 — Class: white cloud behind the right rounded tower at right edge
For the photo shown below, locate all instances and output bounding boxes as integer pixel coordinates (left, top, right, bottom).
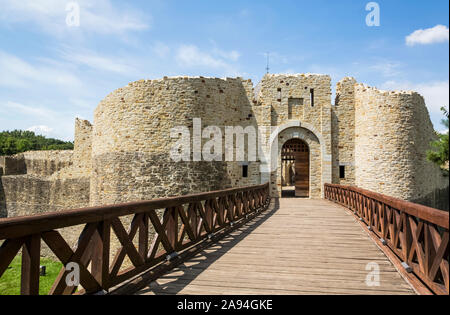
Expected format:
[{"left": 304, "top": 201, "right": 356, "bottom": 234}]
[{"left": 382, "top": 81, "right": 449, "bottom": 117}]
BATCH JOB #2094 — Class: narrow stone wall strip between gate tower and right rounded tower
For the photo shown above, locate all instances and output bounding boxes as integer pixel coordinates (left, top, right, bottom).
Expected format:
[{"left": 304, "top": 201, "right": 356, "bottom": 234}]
[{"left": 331, "top": 78, "right": 356, "bottom": 185}]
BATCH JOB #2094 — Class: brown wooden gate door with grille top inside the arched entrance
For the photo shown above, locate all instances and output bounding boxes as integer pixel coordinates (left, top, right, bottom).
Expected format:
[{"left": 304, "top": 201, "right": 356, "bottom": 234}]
[{"left": 281, "top": 139, "right": 309, "bottom": 198}]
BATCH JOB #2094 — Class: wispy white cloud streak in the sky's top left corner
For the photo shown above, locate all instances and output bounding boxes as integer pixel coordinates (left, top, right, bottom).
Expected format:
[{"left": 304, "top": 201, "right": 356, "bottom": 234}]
[{"left": 0, "top": 0, "right": 150, "bottom": 35}]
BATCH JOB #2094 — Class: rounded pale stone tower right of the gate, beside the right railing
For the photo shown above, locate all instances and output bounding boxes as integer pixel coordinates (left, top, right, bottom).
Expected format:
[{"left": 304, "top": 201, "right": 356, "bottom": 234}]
[{"left": 355, "top": 84, "right": 448, "bottom": 206}]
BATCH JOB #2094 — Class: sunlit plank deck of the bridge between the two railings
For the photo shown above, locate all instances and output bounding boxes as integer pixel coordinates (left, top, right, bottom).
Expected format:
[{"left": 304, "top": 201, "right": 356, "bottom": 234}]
[{"left": 137, "top": 199, "right": 414, "bottom": 295}]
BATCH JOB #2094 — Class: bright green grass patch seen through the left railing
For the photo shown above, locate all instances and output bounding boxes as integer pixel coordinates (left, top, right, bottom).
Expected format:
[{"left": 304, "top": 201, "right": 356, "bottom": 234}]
[{"left": 0, "top": 256, "right": 63, "bottom": 295}]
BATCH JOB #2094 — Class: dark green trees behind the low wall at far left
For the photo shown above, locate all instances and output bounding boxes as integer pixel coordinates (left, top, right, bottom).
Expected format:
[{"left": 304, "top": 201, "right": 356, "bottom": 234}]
[{"left": 0, "top": 130, "right": 73, "bottom": 155}]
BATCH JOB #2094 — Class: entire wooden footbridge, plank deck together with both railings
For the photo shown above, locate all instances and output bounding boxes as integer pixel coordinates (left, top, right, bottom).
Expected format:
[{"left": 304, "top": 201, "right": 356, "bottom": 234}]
[{"left": 0, "top": 184, "right": 449, "bottom": 295}]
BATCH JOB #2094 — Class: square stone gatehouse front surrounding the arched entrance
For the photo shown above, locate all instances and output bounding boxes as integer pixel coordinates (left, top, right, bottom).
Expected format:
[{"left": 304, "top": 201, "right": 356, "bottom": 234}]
[{"left": 254, "top": 74, "right": 332, "bottom": 197}]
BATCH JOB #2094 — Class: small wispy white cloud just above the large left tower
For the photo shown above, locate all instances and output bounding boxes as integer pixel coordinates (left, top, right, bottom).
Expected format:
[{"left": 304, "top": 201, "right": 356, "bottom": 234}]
[{"left": 176, "top": 45, "right": 240, "bottom": 75}]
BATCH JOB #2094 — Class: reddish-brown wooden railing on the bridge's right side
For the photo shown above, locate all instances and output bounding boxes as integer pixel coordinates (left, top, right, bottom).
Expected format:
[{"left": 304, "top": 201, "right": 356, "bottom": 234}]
[{"left": 325, "top": 184, "right": 449, "bottom": 295}]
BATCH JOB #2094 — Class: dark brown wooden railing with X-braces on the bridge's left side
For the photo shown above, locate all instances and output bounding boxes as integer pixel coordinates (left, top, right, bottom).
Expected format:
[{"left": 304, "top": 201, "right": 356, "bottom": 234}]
[{"left": 0, "top": 184, "right": 270, "bottom": 295}]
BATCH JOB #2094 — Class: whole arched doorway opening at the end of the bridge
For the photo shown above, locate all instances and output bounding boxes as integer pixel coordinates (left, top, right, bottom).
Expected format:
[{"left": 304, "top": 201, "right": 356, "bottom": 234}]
[{"left": 281, "top": 139, "right": 309, "bottom": 198}]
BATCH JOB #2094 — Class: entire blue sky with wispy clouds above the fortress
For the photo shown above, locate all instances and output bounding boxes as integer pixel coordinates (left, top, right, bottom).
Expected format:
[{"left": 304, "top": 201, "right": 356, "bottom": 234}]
[{"left": 0, "top": 0, "right": 449, "bottom": 140}]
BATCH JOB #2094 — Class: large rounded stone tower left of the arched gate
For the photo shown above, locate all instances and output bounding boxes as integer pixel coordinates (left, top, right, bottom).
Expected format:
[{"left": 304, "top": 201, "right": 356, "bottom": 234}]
[{"left": 90, "top": 77, "right": 256, "bottom": 205}]
